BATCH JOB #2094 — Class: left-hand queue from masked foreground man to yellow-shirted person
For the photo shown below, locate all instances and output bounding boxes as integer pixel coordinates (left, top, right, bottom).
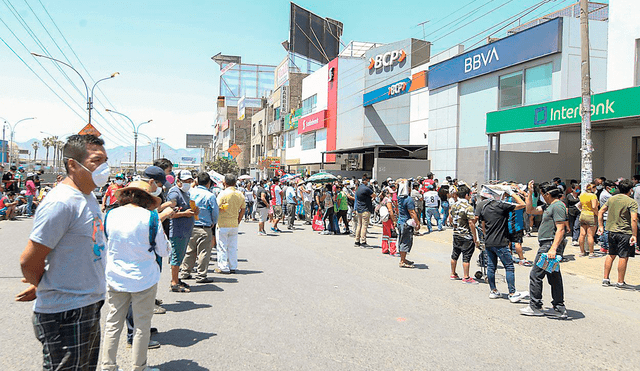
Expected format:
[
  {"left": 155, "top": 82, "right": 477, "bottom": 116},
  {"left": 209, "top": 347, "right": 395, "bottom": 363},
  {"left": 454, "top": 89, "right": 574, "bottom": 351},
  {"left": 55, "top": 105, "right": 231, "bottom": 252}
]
[{"left": 16, "top": 135, "right": 245, "bottom": 371}]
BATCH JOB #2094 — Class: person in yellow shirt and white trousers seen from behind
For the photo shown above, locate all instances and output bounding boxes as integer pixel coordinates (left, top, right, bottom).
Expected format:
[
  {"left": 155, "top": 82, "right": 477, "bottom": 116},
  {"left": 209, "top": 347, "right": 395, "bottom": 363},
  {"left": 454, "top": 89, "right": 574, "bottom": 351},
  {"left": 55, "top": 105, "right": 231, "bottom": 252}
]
[{"left": 215, "top": 174, "right": 246, "bottom": 274}]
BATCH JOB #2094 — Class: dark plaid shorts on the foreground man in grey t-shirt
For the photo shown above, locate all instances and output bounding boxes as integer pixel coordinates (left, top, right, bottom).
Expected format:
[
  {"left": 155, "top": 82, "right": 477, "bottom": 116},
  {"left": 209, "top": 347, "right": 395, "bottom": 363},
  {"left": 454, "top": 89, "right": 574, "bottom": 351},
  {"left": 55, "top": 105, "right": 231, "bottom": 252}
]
[{"left": 33, "top": 300, "right": 104, "bottom": 371}]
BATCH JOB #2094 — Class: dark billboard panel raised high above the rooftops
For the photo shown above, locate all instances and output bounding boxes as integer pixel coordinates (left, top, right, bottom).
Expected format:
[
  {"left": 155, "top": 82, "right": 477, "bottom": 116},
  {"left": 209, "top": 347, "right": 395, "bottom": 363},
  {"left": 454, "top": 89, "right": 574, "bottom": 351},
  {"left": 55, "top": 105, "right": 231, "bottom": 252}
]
[{"left": 289, "top": 3, "right": 343, "bottom": 64}]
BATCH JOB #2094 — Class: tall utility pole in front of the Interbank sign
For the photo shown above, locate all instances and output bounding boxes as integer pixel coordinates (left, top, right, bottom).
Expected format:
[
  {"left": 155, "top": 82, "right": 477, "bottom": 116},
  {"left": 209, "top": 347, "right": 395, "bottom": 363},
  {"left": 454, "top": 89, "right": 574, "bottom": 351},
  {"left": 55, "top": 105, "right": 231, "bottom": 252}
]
[{"left": 580, "top": 0, "right": 593, "bottom": 192}]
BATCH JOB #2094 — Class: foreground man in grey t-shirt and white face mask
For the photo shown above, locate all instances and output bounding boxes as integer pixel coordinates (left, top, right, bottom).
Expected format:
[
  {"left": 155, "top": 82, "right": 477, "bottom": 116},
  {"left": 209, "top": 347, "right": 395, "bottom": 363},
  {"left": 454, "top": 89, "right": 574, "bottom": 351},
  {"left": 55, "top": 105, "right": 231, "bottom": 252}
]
[{"left": 16, "top": 135, "right": 109, "bottom": 370}]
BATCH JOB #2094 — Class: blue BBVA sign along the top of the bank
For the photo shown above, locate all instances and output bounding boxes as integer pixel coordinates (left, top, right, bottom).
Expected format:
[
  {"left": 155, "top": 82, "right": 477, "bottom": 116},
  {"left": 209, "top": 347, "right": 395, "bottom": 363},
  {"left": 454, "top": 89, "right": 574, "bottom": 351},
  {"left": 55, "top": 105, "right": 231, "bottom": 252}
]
[{"left": 429, "top": 18, "right": 562, "bottom": 90}]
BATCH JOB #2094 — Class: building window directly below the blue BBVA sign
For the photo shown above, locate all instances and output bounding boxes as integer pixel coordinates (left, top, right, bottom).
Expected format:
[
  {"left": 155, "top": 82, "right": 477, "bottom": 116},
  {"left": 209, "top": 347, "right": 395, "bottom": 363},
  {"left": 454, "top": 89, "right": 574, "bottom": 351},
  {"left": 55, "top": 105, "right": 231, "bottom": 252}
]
[{"left": 498, "top": 63, "right": 553, "bottom": 109}]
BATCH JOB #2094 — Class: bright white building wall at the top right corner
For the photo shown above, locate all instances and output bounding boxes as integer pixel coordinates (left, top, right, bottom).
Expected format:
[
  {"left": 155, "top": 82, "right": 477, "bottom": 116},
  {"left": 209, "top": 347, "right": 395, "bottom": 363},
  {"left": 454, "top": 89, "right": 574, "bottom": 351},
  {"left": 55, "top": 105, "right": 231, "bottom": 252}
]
[{"left": 607, "top": 0, "right": 640, "bottom": 90}]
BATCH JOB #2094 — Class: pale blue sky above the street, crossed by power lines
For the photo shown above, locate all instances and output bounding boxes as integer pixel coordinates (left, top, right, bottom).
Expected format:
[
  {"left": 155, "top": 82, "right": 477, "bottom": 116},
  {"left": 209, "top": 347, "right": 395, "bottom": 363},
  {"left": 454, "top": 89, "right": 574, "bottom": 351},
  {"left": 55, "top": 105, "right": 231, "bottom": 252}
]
[{"left": 0, "top": 0, "right": 608, "bottom": 148}]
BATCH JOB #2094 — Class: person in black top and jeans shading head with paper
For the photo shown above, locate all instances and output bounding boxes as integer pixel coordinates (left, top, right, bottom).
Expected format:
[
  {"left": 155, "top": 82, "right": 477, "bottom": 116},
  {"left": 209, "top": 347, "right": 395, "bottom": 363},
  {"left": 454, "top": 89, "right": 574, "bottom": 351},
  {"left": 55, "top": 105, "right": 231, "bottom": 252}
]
[{"left": 475, "top": 188, "right": 526, "bottom": 303}]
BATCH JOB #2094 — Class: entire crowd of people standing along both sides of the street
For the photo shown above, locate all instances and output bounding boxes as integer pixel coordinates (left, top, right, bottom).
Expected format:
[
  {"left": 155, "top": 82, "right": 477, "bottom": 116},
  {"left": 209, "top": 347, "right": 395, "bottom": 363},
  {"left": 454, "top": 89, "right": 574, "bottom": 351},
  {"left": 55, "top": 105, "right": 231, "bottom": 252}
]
[{"left": 7, "top": 135, "right": 640, "bottom": 371}]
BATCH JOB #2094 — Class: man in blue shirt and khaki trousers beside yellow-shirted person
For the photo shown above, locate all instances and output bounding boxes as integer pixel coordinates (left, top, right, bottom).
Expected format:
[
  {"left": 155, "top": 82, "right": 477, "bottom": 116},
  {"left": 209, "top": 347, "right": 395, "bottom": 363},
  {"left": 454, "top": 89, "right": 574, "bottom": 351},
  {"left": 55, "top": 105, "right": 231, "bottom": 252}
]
[{"left": 180, "top": 172, "right": 218, "bottom": 283}]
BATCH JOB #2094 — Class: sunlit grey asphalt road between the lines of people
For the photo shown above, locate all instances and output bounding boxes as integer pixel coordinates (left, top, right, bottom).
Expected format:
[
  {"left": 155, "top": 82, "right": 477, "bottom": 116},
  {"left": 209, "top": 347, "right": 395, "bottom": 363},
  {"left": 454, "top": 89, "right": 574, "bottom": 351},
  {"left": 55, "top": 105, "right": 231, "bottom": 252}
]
[{"left": 0, "top": 219, "right": 640, "bottom": 370}]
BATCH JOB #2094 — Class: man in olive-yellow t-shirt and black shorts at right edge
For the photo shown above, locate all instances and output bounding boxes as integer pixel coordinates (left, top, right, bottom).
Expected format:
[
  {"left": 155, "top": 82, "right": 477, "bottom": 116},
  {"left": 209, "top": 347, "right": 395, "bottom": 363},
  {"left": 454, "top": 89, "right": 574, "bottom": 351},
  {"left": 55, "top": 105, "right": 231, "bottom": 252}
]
[{"left": 598, "top": 179, "right": 638, "bottom": 289}]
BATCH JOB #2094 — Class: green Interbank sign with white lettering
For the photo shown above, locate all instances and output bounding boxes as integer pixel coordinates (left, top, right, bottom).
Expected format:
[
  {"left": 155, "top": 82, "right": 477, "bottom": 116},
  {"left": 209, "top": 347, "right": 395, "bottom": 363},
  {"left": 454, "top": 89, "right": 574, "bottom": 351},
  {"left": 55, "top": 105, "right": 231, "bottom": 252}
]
[{"left": 486, "top": 87, "right": 640, "bottom": 134}]
